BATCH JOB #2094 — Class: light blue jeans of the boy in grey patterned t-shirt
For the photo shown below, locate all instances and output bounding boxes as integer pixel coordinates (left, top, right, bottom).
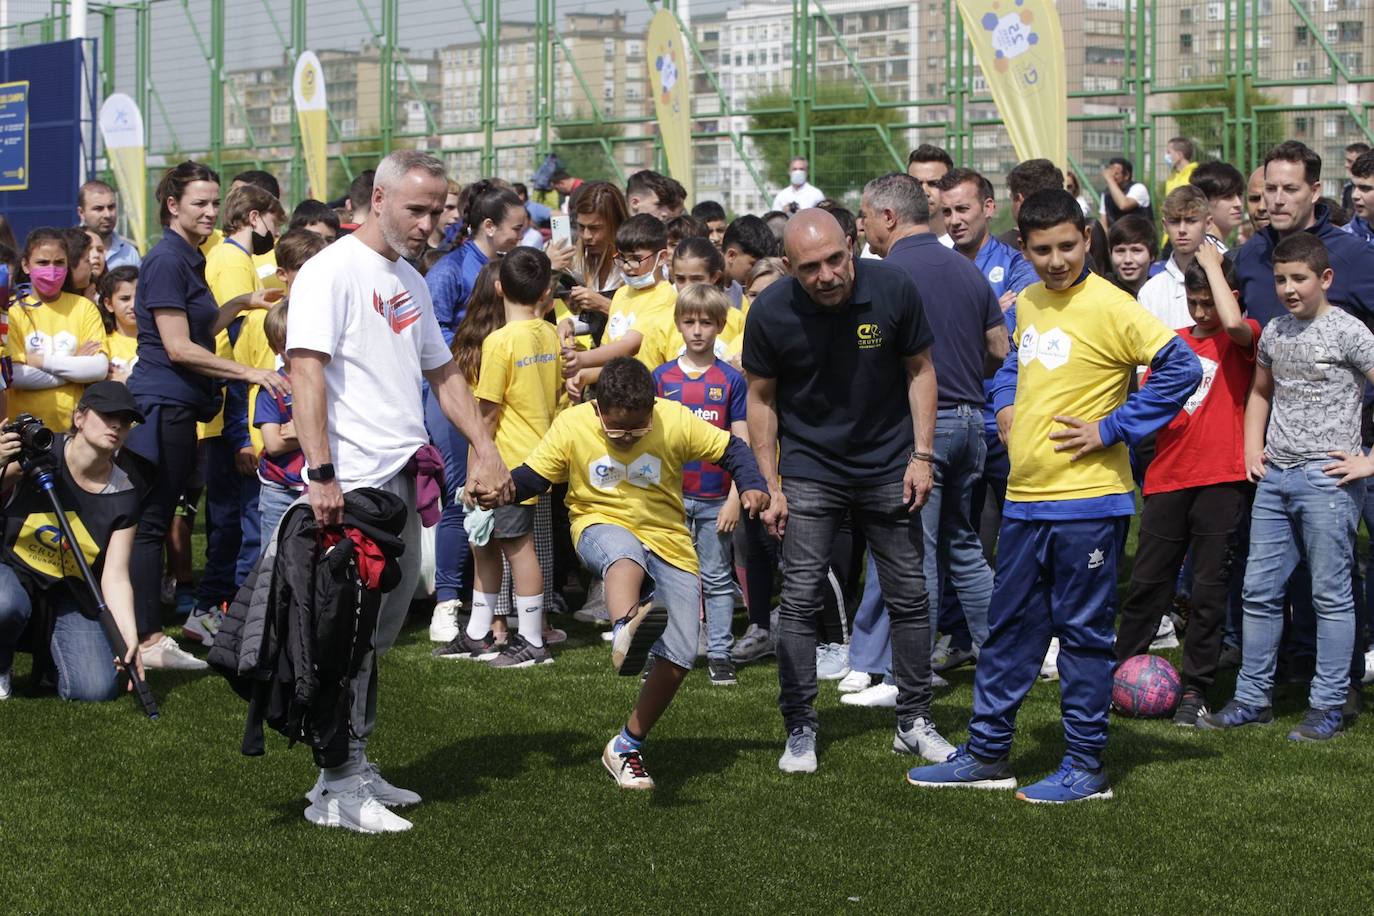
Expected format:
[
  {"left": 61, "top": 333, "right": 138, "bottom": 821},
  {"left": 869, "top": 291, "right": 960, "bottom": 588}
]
[{"left": 1235, "top": 461, "right": 1364, "bottom": 709}]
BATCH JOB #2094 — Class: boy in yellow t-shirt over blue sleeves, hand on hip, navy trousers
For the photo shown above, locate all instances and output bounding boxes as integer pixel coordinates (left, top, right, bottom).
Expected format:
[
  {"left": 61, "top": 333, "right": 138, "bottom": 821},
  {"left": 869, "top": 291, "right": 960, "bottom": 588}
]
[{"left": 907, "top": 190, "right": 1202, "bottom": 803}]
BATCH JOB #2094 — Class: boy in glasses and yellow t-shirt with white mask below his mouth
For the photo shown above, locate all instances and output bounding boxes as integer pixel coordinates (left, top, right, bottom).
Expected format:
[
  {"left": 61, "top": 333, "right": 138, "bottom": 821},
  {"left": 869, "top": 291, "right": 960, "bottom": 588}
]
[{"left": 561, "top": 213, "right": 677, "bottom": 394}]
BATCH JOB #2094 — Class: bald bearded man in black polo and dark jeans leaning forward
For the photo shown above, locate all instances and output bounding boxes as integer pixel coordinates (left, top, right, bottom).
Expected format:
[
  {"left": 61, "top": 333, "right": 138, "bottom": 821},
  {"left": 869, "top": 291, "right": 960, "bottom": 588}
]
[{"left": 743, "top": 210, "right": 954, "bottom": 773}]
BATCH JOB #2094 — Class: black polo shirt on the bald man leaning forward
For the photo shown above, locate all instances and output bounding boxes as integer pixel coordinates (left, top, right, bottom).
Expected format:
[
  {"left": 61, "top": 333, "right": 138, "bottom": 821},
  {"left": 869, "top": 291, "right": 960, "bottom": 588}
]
[{"left": 743, "top": 260, "right": 934, "bottom": 485}]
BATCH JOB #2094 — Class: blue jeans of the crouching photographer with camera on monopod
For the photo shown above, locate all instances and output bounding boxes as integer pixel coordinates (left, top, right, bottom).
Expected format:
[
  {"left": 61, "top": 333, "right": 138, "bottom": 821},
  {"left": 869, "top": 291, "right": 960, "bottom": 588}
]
[{"left": 0, "top": 563, "right": 120, "bottom": 700}]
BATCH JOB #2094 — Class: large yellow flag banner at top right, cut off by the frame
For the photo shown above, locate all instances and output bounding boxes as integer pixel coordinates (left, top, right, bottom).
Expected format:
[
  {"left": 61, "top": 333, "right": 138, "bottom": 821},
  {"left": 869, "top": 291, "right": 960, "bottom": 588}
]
[{"left": 956, "top": 0, "right": 1069, "bottom": 169}]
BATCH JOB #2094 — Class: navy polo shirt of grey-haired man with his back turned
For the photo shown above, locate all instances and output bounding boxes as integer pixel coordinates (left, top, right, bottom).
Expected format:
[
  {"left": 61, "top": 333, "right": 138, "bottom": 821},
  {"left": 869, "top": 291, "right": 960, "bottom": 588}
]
[{"left": 882, "top": 232, "right": 1006, "bottom": 408}]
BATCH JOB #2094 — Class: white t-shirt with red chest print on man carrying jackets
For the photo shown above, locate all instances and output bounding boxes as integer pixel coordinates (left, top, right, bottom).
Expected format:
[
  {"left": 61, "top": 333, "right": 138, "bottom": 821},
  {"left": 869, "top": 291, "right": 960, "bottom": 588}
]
[{"left": 286, "top": 235, "right": 452, "bottom": 490}]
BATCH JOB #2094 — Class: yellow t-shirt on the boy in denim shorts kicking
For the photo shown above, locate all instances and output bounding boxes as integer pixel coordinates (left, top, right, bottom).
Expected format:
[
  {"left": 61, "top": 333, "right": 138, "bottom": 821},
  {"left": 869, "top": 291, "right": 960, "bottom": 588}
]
[{"left": 525, "top": 398, "right": 730, "bottom": 573}]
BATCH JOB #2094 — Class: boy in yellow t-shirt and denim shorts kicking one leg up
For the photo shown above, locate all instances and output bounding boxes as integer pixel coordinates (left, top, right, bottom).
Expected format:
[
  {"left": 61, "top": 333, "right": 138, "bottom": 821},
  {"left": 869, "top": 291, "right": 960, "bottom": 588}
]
[{"left": 500, "top": 357, "right": 768, "bottom": 788}]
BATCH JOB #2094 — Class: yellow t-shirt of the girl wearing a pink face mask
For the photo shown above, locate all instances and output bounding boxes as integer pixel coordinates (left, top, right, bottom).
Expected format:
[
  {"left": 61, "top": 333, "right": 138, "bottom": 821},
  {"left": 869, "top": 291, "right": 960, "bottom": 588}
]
[{"left": 5, "top": 293, "right": 110, "bottom": 433}]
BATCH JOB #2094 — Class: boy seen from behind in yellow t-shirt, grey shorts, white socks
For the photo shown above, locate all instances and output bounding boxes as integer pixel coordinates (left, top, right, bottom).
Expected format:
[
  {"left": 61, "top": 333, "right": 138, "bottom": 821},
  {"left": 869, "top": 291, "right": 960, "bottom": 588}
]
[{"left": 441, "top": 247, "right": 562, "bottom": 667}]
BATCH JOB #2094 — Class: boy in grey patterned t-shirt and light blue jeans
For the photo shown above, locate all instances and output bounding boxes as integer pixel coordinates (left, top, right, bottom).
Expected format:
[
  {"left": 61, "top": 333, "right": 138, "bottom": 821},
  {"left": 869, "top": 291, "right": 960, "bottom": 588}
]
[{"left": 1198, "top": 232, "right": 1374, "bottom": 742}]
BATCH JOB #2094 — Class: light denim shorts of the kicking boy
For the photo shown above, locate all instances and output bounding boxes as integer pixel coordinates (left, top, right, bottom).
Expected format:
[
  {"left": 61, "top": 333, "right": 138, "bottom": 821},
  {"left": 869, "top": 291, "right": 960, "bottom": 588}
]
[{"left": 577, "top": 525, "right": 701, "bottom": 669}]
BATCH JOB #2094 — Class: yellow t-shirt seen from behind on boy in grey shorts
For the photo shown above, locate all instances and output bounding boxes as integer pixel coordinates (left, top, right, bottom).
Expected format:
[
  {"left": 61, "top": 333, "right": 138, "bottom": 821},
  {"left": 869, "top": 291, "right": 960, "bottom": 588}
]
[{"left": 473, "top": 319, "right": 563, "bottom": 497}]
